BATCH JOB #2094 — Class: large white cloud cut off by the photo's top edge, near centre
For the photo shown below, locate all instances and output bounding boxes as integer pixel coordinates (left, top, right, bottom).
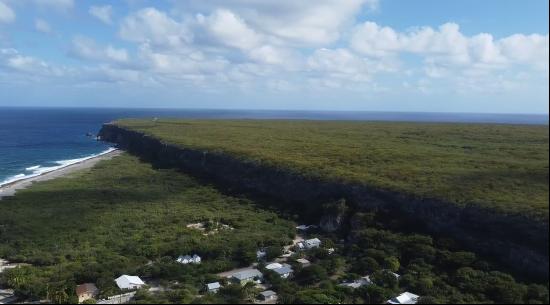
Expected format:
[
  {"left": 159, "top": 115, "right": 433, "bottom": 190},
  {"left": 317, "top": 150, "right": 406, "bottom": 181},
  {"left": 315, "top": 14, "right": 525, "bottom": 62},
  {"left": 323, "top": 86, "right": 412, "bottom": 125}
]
[{"left": 175, "top": 0, "right": 378, "bottom": 46}]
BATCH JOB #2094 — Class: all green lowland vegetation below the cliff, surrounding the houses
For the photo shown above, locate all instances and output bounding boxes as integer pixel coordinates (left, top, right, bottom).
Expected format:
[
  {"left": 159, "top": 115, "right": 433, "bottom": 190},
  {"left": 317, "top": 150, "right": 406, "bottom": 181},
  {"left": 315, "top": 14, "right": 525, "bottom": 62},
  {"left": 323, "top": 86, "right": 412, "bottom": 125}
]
[{"left": 0, "top": 154, "right": 548, "bottom": 304}]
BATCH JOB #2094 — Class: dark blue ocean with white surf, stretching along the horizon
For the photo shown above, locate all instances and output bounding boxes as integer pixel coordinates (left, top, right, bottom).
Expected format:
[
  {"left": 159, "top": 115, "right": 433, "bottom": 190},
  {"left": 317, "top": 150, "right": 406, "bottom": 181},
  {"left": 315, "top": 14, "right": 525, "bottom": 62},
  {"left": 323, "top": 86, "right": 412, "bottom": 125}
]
[{"left": 0, "top": 107, "right": 548, "bottom": 186}]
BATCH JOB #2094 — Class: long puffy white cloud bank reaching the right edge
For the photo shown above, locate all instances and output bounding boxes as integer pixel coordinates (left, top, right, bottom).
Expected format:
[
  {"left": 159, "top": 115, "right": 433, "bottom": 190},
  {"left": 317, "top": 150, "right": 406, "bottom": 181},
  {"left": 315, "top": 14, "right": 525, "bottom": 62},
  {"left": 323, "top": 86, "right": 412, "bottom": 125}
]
[{"left": 351, "top": 22, "right": 548, "bottom": 68}]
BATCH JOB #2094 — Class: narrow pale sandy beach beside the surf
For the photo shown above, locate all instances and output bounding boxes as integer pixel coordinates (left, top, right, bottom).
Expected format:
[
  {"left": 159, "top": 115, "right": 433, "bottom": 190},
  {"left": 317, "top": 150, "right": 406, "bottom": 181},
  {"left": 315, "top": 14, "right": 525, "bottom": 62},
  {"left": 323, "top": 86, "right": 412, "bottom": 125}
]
[{"left": 0, "top": 149, "right": 122, "bottom": 200}]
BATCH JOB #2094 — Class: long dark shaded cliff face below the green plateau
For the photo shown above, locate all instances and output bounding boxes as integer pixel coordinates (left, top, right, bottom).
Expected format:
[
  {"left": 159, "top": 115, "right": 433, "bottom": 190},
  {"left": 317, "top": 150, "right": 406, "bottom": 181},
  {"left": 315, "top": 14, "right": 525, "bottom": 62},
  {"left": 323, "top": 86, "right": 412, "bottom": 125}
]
[{"left": 99, "top": 124, "right": 549, "bottom": 280}]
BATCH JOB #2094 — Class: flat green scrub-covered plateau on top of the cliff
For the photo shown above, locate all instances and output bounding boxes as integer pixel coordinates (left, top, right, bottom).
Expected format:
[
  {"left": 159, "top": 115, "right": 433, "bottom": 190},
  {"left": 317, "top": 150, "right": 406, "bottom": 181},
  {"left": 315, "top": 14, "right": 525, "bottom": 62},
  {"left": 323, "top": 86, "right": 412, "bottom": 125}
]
[{"left": 116, "top": 120, "right": 549, "bottom": 221}]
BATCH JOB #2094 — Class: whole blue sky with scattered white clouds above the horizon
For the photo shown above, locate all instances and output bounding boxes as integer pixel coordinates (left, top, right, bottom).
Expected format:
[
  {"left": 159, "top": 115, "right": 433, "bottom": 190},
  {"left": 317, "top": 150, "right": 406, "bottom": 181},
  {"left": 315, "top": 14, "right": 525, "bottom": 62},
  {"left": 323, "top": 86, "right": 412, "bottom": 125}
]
[{"left": 0, "top": 0, "right": 549, "bottom": 114}]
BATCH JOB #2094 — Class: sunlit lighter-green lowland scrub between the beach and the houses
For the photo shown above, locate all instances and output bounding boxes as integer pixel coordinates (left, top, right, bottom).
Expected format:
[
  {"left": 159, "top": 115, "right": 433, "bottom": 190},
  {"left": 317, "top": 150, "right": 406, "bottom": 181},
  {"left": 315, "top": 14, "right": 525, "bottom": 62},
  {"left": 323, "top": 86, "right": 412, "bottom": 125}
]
[{"left": 0, "top": 155, "right": 294, "bottom": 303}]
